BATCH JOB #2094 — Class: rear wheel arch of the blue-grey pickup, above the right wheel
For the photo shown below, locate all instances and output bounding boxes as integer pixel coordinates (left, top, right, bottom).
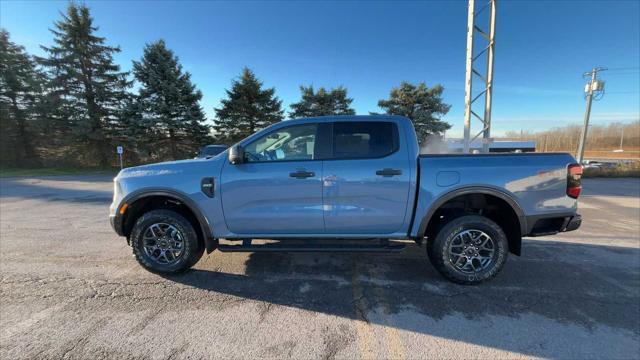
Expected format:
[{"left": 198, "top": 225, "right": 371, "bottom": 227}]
[{"left": 417, "top": 186, "right": 527, "bottom": 255}]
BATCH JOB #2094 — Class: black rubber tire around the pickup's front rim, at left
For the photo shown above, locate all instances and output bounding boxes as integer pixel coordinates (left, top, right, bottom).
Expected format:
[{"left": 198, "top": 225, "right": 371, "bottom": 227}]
[{"left": 131, "top": 209, "right": 204, "bottom": 274}]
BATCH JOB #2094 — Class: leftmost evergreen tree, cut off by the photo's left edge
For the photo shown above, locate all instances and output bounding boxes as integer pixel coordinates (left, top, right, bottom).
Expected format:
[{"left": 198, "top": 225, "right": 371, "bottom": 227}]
[{"left": 0, "top": 29, "right": 44, "bottom": 166}]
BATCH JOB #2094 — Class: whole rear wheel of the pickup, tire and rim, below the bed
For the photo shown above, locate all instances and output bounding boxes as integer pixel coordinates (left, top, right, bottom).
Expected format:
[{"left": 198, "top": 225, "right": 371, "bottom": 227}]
[{"left": 427, "top": 215, "right": 509, "bottom": 285}]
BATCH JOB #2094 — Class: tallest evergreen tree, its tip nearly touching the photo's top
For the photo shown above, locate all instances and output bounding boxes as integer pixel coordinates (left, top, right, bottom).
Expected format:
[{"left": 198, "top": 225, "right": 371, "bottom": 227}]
[{"left": 38, "top": 2, "right": 130, "bottom": 166}]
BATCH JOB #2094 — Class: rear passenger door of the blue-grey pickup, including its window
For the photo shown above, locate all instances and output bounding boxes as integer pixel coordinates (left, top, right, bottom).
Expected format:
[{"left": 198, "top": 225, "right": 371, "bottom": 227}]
[{"left": 323, "top": 121, "right": 415, "bottom": 235}]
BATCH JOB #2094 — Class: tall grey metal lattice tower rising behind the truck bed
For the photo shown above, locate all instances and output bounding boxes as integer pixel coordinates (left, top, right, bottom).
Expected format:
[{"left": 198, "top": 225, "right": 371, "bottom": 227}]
[{"left": 464, "top": 0, "right": 496, "bottom": 153}]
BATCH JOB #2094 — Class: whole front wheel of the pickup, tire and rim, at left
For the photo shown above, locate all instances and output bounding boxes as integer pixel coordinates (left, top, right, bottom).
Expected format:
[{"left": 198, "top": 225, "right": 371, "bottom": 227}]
[{"left": 131, "top": 210, "right": 204, "bottom": 273}]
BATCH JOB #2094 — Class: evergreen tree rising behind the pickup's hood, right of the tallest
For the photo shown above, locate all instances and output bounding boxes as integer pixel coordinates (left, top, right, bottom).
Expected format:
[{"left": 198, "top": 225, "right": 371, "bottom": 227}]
[{"left": 130, "top": 40, "right": 209, "bottom": 159}]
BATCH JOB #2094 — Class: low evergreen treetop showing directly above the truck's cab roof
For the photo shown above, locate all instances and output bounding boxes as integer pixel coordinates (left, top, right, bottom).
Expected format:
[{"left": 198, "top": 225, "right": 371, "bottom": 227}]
[{"left": 289, "top": 86, "right": 356, "bottom": 118}]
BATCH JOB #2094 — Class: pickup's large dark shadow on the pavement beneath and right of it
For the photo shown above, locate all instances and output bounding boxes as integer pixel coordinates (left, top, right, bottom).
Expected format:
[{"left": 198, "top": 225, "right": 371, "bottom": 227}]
[{"left": 167, "top": 241, "right": 640, "bottom": 355}]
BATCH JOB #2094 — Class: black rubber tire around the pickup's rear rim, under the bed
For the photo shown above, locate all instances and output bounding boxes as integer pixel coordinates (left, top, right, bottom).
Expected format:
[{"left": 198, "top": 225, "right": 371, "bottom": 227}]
[{"left": 427, "top": 215, "right": 509, "bottom": 285}]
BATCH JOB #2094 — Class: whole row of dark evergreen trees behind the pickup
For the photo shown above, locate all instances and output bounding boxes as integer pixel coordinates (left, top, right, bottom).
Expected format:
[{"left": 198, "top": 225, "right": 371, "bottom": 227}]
[{"left": 0, "top": 2, "right": 450, "bottom": 167}]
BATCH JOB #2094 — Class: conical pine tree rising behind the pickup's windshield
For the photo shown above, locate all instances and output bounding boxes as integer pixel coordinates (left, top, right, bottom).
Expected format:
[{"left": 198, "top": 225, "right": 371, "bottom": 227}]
[{"left": 214, "top": 68, "right": 284, "bottom": 143}]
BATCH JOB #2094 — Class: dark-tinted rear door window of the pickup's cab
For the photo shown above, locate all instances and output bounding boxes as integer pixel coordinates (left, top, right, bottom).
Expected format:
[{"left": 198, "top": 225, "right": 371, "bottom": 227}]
[{"left": 333, "top": 121, "right": 398, "bottom": 159}]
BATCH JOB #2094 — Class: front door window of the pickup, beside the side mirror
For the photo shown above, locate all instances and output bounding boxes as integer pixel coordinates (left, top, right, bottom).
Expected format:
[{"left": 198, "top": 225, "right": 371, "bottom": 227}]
[{"left": 244, "top": 124, "right": 318, "bottom": 162}]
